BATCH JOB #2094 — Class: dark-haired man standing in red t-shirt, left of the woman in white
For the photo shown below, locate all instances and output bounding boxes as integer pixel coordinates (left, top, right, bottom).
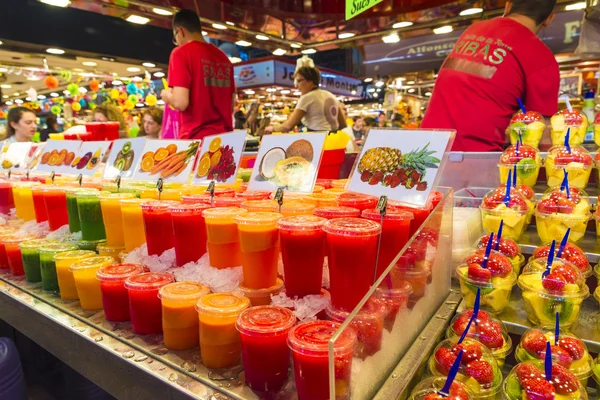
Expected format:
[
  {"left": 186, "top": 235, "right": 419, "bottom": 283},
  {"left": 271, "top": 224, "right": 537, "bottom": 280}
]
[{"left": 161, "top": 10, "right": 235, "bottom": 139}]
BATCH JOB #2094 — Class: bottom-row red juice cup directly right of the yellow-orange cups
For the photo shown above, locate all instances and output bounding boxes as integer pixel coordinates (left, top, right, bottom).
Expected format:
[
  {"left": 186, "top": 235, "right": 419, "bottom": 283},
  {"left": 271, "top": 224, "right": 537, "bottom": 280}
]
[{"left": 96, "top": 264, "right": 144, "bottom": 322}]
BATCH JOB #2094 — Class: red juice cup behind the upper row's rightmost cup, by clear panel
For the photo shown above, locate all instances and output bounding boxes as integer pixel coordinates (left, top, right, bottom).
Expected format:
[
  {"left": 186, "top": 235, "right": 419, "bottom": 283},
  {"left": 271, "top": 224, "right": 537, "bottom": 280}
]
[{"left": 362, "top": 209, "right": 414, "bottom": 278}]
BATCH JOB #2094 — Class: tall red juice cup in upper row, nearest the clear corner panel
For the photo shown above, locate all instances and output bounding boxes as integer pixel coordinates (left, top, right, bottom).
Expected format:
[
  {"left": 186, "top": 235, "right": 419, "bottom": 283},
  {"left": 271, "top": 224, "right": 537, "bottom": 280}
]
[{"left": 323, "top": 218, "right": 381, "bottom": 311}]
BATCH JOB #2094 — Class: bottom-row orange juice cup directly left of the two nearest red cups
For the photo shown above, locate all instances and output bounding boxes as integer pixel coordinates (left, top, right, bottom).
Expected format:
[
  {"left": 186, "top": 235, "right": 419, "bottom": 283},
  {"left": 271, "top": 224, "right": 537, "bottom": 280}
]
[{"left": 196, "top": 293, "right": 250, "bottom": 369}]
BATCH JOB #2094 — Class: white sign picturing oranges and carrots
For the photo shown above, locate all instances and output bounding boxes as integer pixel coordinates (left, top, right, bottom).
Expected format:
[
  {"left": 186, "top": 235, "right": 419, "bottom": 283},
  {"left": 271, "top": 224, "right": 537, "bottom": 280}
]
[{"left": 133, "top": 139, "right": 200, "bottom": 183}]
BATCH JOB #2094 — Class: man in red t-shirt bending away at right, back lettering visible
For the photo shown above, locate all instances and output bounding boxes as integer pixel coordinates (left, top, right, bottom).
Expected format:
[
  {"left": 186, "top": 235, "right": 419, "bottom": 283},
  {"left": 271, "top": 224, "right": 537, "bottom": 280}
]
[{"left": 421, "top": 0, "right": 560, "bottom": 151}]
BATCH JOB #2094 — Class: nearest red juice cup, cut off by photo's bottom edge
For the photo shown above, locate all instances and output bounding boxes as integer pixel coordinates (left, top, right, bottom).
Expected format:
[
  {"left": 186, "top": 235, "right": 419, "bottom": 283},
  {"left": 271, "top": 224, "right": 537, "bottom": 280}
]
[{"left": 288, "top": 321, "right": 356, "bottom": 400}]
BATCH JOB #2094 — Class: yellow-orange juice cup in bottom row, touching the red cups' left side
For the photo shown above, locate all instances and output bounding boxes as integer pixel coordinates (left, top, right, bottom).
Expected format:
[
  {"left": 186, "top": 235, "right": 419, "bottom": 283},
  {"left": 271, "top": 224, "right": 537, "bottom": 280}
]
[{"left": 69, "top": 256, "right": 115, "bottom": 311}]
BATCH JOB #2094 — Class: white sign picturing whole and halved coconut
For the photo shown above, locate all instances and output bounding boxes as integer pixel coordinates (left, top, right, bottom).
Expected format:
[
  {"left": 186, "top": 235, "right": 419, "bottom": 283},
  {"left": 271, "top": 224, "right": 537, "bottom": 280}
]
[{"left": 248, "top": 132, "right": 327, "bottom": 193}]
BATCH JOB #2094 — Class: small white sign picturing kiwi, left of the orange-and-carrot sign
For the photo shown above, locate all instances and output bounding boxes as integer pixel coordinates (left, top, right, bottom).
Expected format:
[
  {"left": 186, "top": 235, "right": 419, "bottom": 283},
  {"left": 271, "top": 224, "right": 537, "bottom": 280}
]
[{"left": 104, "top": 138, "right": 146, "bottom": 179}]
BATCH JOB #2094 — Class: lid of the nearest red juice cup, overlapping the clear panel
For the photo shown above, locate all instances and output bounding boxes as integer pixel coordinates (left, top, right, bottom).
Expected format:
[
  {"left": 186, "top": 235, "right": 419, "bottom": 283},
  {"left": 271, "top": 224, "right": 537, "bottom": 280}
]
[{"left": 288, "top": 321, "right": 356, "bottom": 355}]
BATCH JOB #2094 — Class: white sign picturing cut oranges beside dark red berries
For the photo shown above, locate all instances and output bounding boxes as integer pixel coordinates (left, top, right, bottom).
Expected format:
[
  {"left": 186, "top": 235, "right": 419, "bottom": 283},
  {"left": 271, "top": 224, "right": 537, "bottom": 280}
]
[{"left": 192, "top": 130, "right": 246, "bottom": 185}]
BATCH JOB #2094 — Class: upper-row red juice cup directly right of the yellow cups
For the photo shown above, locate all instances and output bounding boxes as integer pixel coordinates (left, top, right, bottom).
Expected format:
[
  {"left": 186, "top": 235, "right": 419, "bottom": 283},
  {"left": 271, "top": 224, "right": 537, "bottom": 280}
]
[{"left": 142, "top": 201, "right": 179, "bottom": 256}]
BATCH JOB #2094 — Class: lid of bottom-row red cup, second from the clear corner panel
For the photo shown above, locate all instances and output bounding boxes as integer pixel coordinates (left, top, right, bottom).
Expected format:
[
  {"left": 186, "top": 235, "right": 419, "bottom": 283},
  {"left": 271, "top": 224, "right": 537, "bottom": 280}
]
[{"left": 235, "top": 306, "right": 296, "bottom": 336}]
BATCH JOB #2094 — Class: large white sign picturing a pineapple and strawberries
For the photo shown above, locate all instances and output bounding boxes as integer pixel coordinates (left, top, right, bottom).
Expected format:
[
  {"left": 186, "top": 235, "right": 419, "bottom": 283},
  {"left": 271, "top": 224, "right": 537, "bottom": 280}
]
[{"left": 347, "top": 129, "right": 454, "bottom": 206}]
